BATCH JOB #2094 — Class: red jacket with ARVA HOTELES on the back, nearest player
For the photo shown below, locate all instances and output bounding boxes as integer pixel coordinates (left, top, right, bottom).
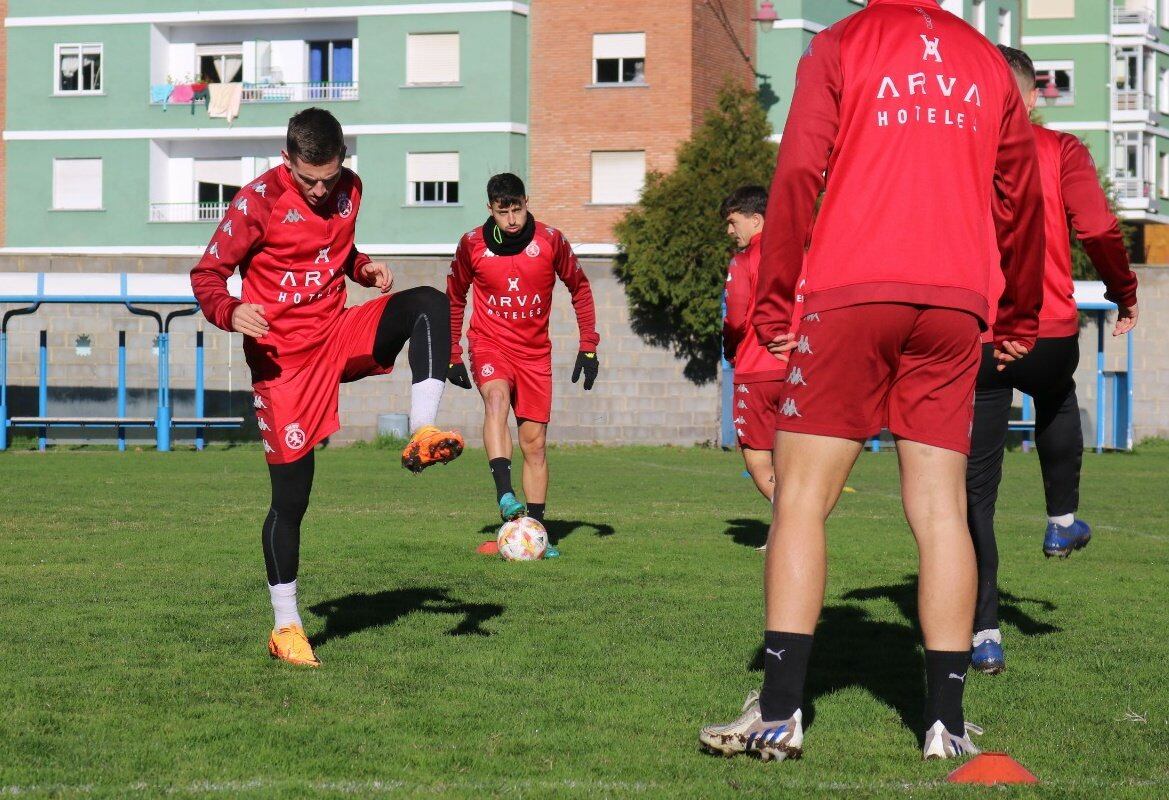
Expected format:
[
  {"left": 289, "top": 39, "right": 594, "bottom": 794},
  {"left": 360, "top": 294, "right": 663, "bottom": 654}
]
[{"left": 753, "top": 0, "right": 1044, "bottom": 346}]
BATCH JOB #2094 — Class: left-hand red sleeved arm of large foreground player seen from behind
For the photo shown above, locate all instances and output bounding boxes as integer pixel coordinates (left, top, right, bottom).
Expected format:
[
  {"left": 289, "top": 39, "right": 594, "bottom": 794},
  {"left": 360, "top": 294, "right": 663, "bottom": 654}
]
[{"left": 750, "top": 25, "right": 844, "bottom": 354}]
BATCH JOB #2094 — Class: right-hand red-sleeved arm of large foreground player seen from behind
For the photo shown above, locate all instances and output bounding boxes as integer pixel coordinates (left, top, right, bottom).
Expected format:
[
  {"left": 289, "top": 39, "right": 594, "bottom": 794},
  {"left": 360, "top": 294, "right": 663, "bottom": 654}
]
[{"left": 994, "top": 78, "right": 1046, "bottom": 368}]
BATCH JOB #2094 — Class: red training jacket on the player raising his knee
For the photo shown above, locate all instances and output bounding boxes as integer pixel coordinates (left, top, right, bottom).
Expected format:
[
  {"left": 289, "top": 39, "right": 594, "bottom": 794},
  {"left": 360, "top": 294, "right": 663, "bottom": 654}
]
[{"left": 191, "top": 165, "right": 369, "bottom": 378}]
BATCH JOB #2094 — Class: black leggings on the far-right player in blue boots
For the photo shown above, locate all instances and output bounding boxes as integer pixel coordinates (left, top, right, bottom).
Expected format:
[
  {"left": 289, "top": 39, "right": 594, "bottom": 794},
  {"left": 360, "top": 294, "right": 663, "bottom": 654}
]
[{"left": 966, "top": 336, "right": 1084, "bottom": 632}]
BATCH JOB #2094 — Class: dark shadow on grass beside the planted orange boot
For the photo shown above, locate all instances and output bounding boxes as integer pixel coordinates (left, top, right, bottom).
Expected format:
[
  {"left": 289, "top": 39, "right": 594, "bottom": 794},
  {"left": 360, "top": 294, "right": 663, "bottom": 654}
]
[{"left": 309, "top": 587, "right": 504, "bottom": 647}]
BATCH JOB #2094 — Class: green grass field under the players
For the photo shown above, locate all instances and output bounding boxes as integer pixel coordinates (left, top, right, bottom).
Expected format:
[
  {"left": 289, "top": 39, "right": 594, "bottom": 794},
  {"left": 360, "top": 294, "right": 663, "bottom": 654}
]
[{"left": 0, "top": 444, "right": 1169, "bottom": 800}]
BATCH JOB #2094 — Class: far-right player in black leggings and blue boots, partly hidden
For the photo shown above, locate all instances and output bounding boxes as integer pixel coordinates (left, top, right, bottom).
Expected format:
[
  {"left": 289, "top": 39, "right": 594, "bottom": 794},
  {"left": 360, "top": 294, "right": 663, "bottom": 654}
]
[{"left": 966, "top": 46, "right": 1137, "bottom": 675}]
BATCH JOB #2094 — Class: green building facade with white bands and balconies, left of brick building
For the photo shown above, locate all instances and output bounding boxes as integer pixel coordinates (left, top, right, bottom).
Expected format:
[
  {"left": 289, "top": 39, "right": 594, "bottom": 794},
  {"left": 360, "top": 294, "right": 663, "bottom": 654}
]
[{"left": 5, "top": 0, "right": 528, "bottom": 254}]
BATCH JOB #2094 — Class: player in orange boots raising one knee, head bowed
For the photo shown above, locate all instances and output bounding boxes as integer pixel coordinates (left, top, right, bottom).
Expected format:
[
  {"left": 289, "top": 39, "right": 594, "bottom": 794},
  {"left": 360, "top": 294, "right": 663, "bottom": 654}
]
[{"left": 191, "top": 109, "right": 463, "bottom": 667}]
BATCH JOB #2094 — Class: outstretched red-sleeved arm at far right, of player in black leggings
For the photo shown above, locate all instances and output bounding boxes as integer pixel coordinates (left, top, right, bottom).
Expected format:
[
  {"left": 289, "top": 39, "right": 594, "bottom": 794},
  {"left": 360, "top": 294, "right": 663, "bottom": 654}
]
[{"left": 1060, "top": 136, "right": 1136, "bottom": 336}]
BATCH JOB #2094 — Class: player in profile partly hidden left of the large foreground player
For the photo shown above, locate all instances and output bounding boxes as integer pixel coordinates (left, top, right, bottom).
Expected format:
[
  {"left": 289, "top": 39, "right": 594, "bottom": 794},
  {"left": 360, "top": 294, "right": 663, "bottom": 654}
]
[{"left": 720, "top": 186, "right": 787, "bottom": 550}]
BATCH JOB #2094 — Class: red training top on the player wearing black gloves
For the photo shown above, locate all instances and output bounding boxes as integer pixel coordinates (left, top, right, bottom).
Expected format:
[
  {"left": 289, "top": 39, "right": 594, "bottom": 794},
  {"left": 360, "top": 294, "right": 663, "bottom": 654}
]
[{"left": 447, "top": 222, "right": 601, "bottom": 361}]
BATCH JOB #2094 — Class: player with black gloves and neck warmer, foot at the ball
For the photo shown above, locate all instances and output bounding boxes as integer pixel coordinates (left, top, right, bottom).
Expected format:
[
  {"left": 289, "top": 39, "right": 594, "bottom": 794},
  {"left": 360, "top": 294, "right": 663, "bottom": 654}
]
[{"left": 447, "top": 173, "right": 601, "bottom": 556}]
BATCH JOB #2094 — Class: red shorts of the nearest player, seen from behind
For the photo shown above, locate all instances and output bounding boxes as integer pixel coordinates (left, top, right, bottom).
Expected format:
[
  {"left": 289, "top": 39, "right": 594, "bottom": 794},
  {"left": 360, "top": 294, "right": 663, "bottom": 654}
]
[{"left": 777, "top": 303, "right": 981, "bottom": 455}]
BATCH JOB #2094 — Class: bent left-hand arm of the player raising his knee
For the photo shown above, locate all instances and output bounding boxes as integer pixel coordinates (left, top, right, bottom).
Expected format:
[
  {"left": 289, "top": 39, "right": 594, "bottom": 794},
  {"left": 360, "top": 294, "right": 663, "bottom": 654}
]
[{"left": 191, "top": 195, "right": 268, "bottom": 339}]
